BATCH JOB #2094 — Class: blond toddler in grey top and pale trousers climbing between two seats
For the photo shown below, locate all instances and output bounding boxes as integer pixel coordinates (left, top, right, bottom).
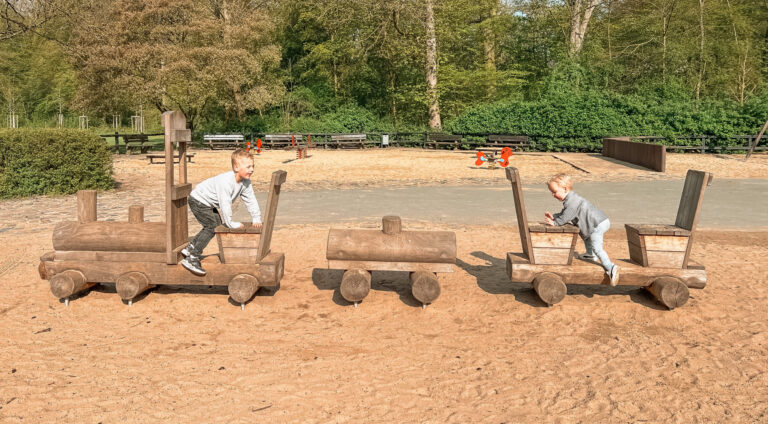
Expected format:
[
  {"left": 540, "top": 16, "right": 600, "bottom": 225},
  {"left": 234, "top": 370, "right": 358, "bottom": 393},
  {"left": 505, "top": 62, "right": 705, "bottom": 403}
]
[{"left": 544, "top": 174, "right": 619, "bottom": 286}]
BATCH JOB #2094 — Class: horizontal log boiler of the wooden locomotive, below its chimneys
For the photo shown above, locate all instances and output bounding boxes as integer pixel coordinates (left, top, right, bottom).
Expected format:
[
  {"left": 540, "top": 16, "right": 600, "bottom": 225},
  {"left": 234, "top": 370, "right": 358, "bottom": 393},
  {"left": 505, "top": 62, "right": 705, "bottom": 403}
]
[{"left": 53, "top": 221, "right": 165, "bottom": 252}]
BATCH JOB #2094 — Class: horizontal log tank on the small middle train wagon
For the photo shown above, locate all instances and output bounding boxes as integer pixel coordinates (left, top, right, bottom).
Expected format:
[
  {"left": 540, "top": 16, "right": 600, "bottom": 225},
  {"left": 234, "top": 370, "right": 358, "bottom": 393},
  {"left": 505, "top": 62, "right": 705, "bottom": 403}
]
[{"left": 326, "top": 229, "right": 456, "bottom": 264}]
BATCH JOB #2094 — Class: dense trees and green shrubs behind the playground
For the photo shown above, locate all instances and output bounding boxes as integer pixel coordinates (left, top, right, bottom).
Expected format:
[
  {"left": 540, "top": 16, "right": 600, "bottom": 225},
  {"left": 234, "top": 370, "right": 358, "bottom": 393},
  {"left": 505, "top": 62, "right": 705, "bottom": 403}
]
[{"left": 0, "top": 0, "right": 768, "bottom": 143}]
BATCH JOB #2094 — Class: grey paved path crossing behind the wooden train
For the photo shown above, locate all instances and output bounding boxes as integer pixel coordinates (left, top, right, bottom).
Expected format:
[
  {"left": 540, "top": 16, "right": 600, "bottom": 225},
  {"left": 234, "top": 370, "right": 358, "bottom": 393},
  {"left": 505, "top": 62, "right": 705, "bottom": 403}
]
[{"left": 235, "top": 179, "right": 768, "bottom": 230}]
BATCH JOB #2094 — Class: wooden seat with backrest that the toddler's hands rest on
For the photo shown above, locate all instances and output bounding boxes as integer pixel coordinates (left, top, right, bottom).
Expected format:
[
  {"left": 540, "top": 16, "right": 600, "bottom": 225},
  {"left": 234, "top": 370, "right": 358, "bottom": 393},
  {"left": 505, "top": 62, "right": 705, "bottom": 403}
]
[{"left": 507, "top": 167, "right": 579, "bottom": 265}]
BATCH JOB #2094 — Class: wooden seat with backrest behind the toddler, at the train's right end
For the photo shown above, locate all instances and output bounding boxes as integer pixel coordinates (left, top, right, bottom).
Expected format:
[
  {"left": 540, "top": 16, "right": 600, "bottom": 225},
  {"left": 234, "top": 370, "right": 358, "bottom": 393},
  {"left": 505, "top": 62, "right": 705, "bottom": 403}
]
[{"left": 624, "top": 169, "right": 712, "bottom": 269}]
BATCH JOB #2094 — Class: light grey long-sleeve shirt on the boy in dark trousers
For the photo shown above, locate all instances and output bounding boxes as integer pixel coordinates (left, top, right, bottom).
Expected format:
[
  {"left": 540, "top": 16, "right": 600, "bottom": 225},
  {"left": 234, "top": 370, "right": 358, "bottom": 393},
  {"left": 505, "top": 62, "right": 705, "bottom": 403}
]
[{"left": 190, "top": 171, "right": 261, "bottom": 228}]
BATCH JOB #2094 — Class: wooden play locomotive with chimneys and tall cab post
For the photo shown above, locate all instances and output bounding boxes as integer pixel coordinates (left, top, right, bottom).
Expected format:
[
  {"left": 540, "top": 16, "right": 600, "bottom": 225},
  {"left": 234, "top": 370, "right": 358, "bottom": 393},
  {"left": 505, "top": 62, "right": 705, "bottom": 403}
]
[{"left": 39, "top": 111, "right": 286, "bottom": 308}]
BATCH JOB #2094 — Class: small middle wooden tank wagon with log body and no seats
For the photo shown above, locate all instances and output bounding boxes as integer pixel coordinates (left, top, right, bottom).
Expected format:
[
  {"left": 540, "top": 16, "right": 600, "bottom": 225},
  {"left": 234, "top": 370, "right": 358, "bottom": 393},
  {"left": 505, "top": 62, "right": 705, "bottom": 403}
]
[{"left": 326, "top": 216, "right": 456, "bottom": 308}]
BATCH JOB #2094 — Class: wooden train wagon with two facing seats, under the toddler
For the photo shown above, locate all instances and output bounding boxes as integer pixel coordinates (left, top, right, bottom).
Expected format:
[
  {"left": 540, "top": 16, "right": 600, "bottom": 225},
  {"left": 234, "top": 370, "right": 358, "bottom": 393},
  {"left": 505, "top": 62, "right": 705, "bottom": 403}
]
[{"left": 506, "top": 167, "right": 712, "bottom": 309}]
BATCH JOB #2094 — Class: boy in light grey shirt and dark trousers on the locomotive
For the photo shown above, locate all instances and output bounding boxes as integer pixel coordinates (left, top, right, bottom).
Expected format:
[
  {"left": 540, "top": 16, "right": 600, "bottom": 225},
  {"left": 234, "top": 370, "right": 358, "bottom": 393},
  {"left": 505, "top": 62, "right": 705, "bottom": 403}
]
[{"left": 181, "top": 149, "right": 261, "bottom": 276}]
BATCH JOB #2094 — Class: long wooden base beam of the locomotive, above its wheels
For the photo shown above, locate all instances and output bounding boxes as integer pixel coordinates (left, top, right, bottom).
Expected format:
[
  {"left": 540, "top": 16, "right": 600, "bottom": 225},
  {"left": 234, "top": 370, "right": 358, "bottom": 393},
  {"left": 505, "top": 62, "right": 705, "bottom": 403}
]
[{"left": 42, "top": 253, "right": 285, "bottom": 287}]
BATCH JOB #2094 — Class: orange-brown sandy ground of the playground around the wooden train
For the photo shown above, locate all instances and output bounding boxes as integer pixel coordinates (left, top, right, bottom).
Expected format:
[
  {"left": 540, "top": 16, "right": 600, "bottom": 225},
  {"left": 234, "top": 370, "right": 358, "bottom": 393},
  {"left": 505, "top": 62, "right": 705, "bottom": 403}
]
[{"left": 0, "top": 150, "right": 768, "bottom": 423}]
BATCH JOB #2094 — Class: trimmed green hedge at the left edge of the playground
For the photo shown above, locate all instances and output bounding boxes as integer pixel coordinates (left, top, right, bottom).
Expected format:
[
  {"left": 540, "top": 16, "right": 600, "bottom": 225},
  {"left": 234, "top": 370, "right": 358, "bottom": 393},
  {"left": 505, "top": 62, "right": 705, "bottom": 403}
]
[{"left": 0, "top": 128, "right": 113, "bottom": 198}]
